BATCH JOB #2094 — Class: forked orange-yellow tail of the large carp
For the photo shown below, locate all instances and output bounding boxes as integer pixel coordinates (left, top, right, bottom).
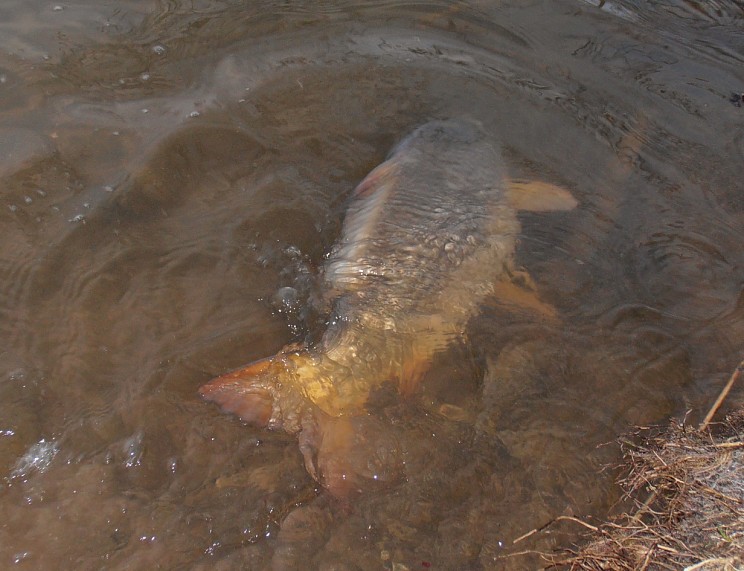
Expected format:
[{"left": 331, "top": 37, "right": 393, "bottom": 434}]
[{"left": 199, "top": 347, "right": 402, "bottom": 498}]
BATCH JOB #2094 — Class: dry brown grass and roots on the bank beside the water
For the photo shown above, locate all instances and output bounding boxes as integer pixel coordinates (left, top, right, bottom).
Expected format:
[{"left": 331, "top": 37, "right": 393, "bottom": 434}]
[{"left": 543, "top": 362, "right": 744, "bottom": 571}]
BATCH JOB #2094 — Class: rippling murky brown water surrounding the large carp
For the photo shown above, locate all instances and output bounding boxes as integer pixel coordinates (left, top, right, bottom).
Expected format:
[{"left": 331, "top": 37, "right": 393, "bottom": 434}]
[{"left": 0, "top": 0, "right": 744, "bottom": 570}]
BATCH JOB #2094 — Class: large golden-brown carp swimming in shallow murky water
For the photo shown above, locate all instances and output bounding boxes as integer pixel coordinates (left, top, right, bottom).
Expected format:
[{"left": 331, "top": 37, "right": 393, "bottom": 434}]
[{"left": 199, "top": 118, "right": 577, "bottom": 496}]
